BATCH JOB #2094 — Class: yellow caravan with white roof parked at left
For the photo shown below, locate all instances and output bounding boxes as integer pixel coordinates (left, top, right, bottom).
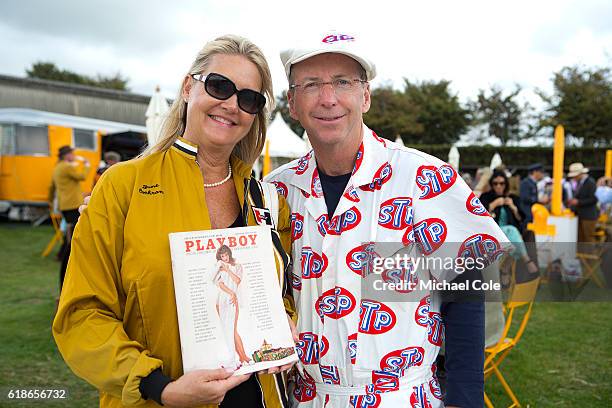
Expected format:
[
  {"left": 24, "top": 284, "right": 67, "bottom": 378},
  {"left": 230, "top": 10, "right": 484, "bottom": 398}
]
[{"left": 0, "top": 108, "right": 146, "bottom": 220}]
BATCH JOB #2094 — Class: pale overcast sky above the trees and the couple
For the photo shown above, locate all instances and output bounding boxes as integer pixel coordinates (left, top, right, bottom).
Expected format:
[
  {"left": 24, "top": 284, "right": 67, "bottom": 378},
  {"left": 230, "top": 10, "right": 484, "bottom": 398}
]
[{"left": 0, "top": 0, "right": 612, "bottom": 107}]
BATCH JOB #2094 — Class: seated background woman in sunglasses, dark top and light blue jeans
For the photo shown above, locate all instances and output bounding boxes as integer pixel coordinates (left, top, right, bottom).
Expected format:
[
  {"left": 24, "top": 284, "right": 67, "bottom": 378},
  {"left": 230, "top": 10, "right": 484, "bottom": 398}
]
[{"left": 480, "top": 170, "right": 538, "bottom": 273}]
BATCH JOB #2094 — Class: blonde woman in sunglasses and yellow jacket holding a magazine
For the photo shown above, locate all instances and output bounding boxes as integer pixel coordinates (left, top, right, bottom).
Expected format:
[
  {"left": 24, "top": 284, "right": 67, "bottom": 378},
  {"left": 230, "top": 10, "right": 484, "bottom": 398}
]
[{"left": 53, "top": 36, "right": 292, "bottom": 407}]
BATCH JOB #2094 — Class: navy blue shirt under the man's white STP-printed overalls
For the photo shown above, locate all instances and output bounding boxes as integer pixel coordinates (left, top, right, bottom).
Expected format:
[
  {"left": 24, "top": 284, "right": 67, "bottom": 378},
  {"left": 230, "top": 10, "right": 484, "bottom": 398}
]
[{"left": 319, "top": 169, "right": 485, "bottom": 408}]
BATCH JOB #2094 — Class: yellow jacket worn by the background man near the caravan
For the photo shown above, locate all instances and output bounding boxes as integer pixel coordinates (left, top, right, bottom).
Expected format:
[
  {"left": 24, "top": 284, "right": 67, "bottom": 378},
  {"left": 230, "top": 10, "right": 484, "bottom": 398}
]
[{"left": 49, "top": 160, "right": 89, "bottom": 211}]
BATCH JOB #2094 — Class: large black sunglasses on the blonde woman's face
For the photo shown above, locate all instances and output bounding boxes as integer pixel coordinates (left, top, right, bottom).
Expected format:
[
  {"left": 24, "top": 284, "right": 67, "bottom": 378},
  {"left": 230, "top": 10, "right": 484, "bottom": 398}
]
[{"left": 191, "top": 72, "right": 266, "bottom": 115}]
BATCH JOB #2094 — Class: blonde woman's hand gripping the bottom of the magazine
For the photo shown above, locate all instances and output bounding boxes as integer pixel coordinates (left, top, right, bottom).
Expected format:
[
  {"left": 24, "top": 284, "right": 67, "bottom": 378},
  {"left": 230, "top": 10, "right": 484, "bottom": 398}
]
[{"left": 161, "top": 368, "right": 249, "bottom": 408}]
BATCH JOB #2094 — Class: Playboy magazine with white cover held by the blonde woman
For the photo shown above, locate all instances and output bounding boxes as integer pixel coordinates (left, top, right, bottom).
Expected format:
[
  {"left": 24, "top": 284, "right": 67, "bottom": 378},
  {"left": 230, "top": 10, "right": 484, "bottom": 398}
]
[{"left": 169, "top": 226, "right": 297, "bottom": 375}]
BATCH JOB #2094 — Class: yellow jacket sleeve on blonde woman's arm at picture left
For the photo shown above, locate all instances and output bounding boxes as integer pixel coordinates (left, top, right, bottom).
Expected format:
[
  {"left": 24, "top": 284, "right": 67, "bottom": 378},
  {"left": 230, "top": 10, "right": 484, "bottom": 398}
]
[{"left": 52, "top": 168, "right": 162, "bottom": 406}]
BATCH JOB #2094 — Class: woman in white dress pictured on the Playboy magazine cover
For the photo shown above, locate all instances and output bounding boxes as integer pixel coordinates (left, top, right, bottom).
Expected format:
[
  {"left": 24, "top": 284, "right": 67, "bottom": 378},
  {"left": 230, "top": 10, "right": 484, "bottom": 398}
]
[{"left": 213, "top": 245, "right": 251, "bottom": 366}]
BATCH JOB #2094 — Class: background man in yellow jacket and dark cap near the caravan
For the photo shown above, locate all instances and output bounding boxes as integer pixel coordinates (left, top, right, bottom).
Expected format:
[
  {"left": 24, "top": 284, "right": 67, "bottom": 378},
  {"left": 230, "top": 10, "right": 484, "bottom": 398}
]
[{"left": 49, "top": 146, "right": 90, "bottom": 291}]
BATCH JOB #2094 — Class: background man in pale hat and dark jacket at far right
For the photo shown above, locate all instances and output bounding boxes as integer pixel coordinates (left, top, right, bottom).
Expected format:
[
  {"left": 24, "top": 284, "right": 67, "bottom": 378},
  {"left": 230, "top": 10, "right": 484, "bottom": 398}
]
[{"left": 567, "top": 163, "right": 599, "bottom": 242}]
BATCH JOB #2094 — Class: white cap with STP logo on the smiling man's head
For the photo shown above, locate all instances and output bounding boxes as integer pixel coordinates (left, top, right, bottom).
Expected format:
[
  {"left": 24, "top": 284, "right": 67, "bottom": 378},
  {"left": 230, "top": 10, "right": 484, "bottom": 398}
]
[{"left": 280, "top": 31, "right": 376, "bottom": 81}]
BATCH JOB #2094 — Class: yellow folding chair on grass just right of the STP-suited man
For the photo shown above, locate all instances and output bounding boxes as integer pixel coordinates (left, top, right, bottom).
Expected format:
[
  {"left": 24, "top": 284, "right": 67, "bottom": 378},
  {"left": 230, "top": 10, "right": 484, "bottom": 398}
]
[{"left": 484, "top": 278, "right": 540, "bottom": 408}]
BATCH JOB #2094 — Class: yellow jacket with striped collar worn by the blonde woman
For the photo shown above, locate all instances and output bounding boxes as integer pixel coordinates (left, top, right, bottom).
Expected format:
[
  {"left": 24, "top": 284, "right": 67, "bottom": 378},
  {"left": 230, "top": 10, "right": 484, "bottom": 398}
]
[{"left": 53, "top": 138, "right": 294, "bottom": 407}]
